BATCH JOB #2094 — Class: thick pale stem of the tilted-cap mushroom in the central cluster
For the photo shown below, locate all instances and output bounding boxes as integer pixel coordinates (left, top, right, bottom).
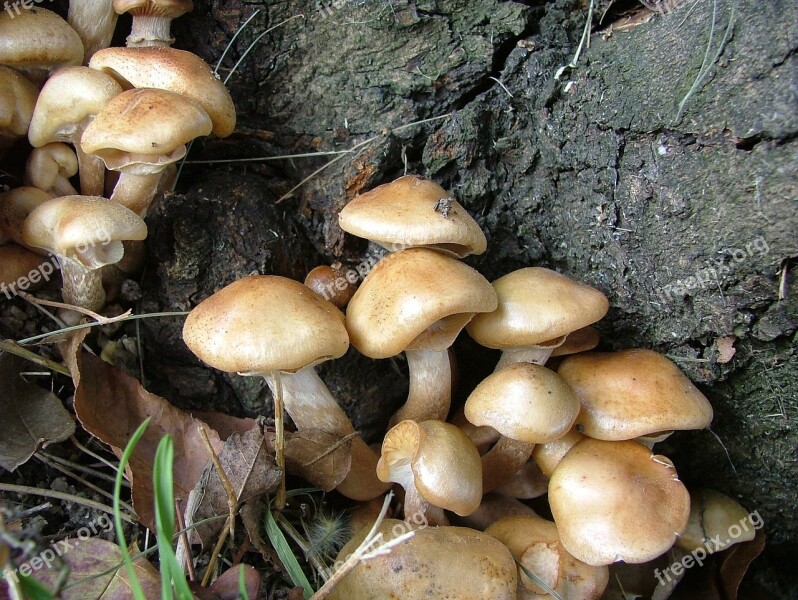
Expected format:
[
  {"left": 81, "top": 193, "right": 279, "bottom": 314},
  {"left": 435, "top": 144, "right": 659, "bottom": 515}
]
[{"left": 389, "top": 349, "right": 452, "bottom": 427}]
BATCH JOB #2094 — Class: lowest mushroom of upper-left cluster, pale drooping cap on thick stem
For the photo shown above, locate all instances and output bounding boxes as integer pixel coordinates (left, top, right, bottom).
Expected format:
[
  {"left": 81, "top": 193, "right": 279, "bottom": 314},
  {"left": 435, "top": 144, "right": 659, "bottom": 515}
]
[{"left": 22, "top": 196, "right": 147, "bottom": 311}]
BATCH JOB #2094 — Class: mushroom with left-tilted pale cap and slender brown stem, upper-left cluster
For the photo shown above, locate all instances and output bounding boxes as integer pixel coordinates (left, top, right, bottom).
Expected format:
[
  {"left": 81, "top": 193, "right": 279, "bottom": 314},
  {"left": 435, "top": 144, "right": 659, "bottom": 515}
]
[{"left": 28, "top": 67, "right": 122, "bottom": 196}]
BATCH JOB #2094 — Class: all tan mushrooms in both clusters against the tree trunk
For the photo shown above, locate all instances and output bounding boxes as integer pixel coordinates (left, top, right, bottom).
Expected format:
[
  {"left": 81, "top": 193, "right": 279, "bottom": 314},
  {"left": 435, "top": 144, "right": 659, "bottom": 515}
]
[{"left": 0, "top": 5, "right": 764, "bottom": 599}]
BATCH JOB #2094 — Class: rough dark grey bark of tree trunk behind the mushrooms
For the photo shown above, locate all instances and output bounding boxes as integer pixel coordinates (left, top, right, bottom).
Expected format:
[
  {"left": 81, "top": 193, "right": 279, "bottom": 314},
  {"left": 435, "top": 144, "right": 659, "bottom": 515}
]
[{"left": 1, "top": 0, "right": 798, "bottom": 598}]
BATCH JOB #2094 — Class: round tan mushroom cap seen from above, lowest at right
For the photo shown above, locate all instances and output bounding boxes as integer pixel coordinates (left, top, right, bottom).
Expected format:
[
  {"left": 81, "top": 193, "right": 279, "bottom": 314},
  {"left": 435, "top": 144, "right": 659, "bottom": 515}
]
[{"left": 549, "top": 438, "right": 690, "bottom": 566}]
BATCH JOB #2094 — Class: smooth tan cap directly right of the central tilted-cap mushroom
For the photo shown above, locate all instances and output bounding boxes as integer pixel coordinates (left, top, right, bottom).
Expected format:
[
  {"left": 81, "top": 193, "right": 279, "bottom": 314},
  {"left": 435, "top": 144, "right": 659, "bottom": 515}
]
[{"left": 466, "top": 267, "right": 609, "bottom": 349}]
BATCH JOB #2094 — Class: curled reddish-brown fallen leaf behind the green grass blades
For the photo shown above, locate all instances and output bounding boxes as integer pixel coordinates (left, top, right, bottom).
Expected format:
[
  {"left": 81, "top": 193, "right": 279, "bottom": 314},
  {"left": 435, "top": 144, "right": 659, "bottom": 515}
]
[{"left": 62, "top": 330, "right": 223, "bottom": 529}]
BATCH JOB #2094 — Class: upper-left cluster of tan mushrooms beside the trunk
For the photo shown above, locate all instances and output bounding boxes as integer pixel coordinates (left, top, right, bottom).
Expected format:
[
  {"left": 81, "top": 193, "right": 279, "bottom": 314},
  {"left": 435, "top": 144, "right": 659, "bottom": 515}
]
[{"left": 0, "top": 0, "right": 236, "bottom": 320}]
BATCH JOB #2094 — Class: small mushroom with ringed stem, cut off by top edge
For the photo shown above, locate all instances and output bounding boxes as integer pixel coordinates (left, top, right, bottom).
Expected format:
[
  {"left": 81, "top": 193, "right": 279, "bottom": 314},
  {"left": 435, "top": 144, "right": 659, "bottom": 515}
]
[{"left": 113, "top": 0, "right": 194, "bottom": 47}]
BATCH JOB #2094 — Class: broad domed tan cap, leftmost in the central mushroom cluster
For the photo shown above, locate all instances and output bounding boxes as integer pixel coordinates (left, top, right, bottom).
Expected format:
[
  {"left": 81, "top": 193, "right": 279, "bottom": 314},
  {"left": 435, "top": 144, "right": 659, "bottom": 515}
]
[{"left": 183, "top": 275, "right": 349, "bottom": 374}]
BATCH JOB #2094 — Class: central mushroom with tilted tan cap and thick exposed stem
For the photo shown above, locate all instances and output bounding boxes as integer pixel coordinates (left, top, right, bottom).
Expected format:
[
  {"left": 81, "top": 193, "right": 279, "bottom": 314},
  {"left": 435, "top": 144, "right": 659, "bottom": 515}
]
[{"left": 346, "top": 248, "right": 496, "bottom": 424}]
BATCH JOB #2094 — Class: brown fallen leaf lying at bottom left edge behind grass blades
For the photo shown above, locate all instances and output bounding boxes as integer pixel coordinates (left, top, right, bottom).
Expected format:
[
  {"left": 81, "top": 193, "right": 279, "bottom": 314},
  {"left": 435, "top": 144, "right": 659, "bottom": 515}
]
[{"left": 29, "top": 538, "right": 161, "bottom": 600}]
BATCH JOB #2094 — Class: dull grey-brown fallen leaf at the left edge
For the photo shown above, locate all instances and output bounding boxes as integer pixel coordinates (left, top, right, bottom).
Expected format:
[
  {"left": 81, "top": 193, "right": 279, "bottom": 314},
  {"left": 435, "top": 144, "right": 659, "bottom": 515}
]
[{"left": 0, "top": 354, "right": 75, "bottom": 471}]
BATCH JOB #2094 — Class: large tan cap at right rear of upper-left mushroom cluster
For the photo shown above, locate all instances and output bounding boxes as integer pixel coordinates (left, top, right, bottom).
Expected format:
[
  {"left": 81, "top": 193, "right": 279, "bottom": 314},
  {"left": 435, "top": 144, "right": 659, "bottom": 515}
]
[{"left": 89, "top": 47, "right": 236, "bottom": 137}]
